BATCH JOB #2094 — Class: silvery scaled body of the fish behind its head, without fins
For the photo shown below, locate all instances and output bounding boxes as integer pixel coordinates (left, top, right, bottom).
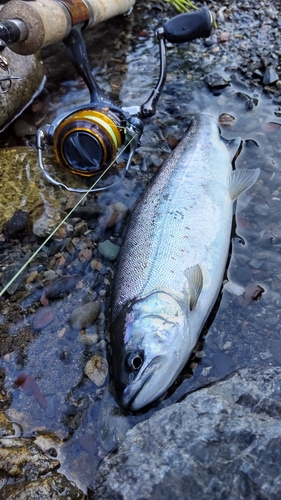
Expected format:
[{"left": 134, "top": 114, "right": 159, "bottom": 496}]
[{"left": 112, "top": 114, "right": 232, "bottom": 328}]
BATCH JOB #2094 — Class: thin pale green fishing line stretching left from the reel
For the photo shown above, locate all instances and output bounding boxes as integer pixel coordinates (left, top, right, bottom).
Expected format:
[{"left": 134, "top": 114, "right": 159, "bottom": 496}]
[{"left": 0, "top": 134, "right": 137, "bottom": 297}]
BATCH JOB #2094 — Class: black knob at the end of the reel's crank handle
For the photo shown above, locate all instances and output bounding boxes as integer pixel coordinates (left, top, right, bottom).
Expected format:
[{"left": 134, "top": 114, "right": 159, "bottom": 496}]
[{"left": 164, "top": 7, "right": 215, "bottom": 43}]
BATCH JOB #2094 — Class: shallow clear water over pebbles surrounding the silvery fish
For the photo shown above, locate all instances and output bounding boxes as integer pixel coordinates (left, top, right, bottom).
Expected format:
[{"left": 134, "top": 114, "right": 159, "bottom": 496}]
[{"left": 0, "top": 0, "right": 281, "bottom": 490}]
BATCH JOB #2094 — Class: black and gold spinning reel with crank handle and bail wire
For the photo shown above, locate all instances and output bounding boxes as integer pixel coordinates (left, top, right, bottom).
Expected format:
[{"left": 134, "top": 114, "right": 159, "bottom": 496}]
[{"left": 37, "top": 7, "right": 215, "bottom": 192}]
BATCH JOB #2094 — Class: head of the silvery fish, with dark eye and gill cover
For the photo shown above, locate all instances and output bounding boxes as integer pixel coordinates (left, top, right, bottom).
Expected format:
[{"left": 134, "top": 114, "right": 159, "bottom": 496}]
[{"left": 111, "top": 291, "right": 189, "bottom": 411}]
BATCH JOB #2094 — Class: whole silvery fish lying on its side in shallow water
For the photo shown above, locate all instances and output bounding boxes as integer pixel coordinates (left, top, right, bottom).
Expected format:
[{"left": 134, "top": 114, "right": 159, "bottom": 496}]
[{"left": 110, "top": 113, "right": 260, "bottom": 412}]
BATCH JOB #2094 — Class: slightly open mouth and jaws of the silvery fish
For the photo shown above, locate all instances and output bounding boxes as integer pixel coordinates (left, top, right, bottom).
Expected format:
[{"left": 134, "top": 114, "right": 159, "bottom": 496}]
[{"left": 120, "top": 355, "right": 164, "bottom": 411}]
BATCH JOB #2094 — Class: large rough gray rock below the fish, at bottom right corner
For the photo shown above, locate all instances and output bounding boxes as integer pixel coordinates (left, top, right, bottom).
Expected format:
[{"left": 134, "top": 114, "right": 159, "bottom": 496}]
[{"left": 93, "top": 367, "right": 281, "bottom": 500}]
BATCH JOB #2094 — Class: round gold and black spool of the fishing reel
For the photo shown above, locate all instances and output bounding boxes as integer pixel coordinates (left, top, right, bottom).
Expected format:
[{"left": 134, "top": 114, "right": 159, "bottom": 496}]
[{"left": 47, "top": 106, "right": 126, "bottom": 177}]
